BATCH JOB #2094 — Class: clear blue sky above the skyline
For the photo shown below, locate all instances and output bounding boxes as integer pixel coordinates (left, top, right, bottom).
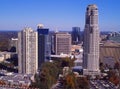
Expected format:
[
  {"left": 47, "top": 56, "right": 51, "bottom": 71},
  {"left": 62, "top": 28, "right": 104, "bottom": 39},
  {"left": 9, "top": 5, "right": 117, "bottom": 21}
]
[{"left": 0, "top": 0, "right": 120, "bottom": 31}]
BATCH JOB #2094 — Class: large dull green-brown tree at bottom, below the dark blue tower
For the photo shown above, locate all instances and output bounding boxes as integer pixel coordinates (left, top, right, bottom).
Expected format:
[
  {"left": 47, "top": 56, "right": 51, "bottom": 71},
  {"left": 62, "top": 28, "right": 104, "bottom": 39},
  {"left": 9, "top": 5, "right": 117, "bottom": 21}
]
[{"left": 35, "top": 62, "right": 58, "bottom": 89}]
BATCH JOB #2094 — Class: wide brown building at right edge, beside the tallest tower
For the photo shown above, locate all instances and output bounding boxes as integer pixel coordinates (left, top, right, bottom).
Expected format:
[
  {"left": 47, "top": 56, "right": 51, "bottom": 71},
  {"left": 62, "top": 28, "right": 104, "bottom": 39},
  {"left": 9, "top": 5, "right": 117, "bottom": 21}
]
[{"left": 100, "top": 41, "right": 120, "bottom": 68}]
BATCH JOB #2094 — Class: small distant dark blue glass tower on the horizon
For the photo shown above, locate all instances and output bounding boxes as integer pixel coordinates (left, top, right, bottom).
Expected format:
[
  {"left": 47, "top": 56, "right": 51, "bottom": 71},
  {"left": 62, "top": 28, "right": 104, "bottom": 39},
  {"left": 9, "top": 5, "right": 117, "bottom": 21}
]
[{"left": 72, "top": 27, "right": 82, "bottom": 45}]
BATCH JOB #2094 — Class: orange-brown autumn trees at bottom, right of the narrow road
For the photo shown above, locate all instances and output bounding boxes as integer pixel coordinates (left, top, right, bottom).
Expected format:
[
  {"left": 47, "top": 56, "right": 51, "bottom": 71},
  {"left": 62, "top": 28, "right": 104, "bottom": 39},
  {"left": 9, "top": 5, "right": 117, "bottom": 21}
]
[{"left": 63, "top": 72, "right": 89, "bottom": 89}]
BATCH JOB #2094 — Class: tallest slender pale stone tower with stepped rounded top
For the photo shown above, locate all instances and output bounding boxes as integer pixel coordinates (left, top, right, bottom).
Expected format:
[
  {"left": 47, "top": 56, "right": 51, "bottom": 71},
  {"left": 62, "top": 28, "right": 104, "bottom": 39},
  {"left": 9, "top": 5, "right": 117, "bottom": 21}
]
[{"left": 83, "top": 4, "right": 99, "bottom": 75}]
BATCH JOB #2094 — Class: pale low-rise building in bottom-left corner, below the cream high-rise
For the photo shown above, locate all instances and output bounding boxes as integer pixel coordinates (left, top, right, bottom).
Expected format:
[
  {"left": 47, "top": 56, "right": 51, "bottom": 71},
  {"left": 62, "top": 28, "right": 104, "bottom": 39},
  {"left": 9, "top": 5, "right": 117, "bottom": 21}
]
[{"left": 0, "top": 73, "right": 33, "bottom": 88}]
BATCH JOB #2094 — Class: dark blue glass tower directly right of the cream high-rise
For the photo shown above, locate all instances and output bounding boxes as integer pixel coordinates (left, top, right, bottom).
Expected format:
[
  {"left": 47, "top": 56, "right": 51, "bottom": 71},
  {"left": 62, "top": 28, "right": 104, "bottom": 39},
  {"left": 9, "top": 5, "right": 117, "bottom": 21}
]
[{"left": 37, "top": 24, "right": 51, "bottom": 69}]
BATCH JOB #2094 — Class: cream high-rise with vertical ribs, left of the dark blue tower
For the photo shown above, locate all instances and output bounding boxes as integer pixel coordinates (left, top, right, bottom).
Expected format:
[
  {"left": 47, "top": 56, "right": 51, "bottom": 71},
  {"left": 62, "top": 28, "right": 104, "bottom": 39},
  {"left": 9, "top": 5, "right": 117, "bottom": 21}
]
[{"left": 18, "top": 28, "right": 38, "bottom": 74}]
